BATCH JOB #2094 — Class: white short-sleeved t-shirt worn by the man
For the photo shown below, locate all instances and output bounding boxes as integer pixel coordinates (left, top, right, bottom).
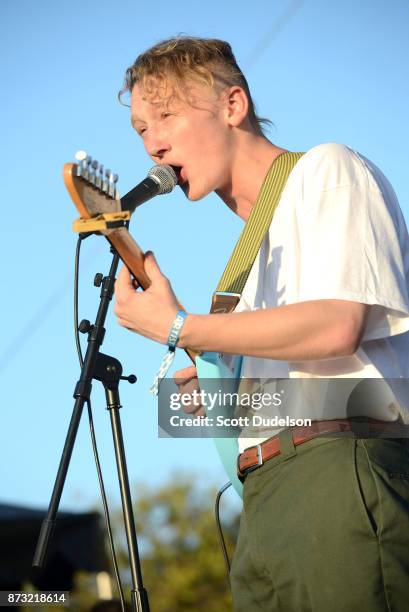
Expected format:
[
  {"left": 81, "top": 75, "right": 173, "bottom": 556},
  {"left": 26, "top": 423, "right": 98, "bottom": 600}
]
[{"left": 236, "top": 143, "right": 409, "bottom": 452}]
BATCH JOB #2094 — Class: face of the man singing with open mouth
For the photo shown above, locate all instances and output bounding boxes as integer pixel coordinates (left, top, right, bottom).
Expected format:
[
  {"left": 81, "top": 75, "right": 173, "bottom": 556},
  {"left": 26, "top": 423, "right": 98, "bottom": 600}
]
[{"left": 131, "top": 79, "right": 232, "bottom": 200}]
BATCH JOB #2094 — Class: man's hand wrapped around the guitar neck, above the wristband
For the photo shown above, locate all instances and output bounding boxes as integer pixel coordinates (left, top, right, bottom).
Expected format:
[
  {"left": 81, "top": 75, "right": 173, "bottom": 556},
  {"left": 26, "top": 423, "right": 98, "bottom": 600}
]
[{"left": 114, "top": 251, "right": 179, "bottom": 344}]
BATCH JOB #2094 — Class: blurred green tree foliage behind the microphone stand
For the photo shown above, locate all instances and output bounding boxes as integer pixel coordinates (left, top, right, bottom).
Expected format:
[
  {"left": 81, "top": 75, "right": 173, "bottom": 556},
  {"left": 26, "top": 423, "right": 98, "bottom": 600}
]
[{"left": 116, "top": 476, "right": 239, "bottom": 612}]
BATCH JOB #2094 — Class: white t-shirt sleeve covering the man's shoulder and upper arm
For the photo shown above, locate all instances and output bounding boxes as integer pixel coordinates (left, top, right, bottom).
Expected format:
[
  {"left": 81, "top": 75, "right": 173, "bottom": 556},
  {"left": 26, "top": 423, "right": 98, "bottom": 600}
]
[{"left": 297, "top": 145, "right": 409, "bottom": 341}]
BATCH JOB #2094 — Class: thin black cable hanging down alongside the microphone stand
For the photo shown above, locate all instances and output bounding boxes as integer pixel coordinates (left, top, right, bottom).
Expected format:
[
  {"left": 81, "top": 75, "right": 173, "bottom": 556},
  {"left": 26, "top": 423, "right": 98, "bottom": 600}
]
[{"left": 74, "top": 235, "right": 125, "bottom": 612}]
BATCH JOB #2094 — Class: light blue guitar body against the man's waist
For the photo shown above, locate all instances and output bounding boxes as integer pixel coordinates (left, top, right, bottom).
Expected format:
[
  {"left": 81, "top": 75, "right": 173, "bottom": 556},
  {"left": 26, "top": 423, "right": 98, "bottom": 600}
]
[{"left": 196, "top": 352, "right": 243, "bottom": 497}]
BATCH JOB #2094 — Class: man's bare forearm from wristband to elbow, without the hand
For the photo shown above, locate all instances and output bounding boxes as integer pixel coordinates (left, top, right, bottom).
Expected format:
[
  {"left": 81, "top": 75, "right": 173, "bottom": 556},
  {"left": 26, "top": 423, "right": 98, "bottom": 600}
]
[{"left": 178, "top": 300, "right": 369, "bottom": 361}]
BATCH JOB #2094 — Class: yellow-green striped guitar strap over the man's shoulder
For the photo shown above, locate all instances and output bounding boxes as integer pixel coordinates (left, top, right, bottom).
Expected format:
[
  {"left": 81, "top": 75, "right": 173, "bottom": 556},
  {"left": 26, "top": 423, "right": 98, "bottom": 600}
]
[{"left": 216, "top": 151, "right": 304, "bottom": 295}]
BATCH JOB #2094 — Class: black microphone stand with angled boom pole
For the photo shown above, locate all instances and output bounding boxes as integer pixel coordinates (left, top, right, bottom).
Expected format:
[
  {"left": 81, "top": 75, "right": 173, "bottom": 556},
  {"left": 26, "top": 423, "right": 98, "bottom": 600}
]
[{"left": 33, "top": 241, "right": 149, "bottom": 612}]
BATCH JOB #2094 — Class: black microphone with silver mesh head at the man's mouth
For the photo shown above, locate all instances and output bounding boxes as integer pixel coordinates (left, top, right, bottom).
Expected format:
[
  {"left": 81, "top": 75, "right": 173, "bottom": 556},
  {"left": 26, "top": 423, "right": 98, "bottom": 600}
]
[{"left": 121, "top": 165, "right": 178, "bottom": 214}]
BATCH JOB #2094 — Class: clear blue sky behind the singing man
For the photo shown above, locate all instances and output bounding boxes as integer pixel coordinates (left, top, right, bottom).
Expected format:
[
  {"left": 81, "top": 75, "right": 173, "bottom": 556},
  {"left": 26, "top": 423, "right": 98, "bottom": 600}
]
[{"left": 0, "top": 0, "right": 409, "bottom": 510}]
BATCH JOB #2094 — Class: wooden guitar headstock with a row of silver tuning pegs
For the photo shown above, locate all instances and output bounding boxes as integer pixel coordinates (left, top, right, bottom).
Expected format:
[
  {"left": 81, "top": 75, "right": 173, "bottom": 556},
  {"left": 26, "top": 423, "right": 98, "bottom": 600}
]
[{"left": 63, "top": 151, "right": 121, "bottom": 219}]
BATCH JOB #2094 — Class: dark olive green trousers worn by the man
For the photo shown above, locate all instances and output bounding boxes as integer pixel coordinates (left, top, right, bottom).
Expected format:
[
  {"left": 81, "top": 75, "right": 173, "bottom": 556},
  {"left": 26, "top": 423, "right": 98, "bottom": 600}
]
[{"left": 231, "top": 430, "right": 409, "bottom": 612}]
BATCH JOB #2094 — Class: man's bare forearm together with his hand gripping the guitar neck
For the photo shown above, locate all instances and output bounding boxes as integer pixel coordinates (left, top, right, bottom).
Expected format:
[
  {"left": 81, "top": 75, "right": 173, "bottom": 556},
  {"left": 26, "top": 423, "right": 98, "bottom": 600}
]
[{"left": 115, "top": 254, "right": 369, "bottom": 361}]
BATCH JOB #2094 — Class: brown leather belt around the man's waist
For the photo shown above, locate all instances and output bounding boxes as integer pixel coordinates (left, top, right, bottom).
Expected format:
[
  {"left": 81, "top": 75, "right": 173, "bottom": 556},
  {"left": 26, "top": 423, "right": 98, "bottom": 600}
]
[{"left": 237, "top": 417, "right": 409, "bottom": 481}]
